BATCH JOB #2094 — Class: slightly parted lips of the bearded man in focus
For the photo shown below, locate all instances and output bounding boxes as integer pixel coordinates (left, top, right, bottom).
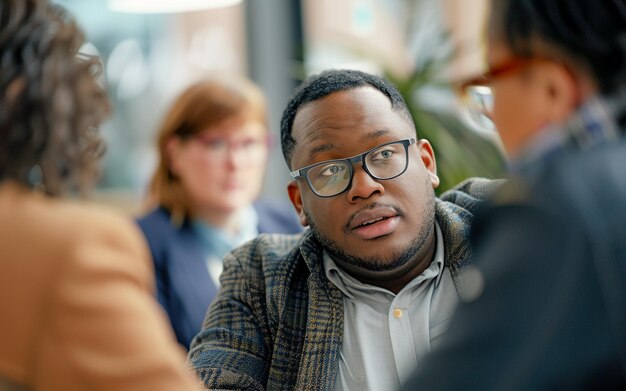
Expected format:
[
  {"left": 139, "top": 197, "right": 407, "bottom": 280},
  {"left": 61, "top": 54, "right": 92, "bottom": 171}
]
[{"left": 347, "top": 206, "right": 400, "bottom": 239}]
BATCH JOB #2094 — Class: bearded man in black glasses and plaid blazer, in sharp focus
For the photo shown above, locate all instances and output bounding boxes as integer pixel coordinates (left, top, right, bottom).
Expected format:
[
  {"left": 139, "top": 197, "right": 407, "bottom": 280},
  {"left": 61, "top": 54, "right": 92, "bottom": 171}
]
[{"left": 189, "top": 70, "right": 495, "bottom": 390}]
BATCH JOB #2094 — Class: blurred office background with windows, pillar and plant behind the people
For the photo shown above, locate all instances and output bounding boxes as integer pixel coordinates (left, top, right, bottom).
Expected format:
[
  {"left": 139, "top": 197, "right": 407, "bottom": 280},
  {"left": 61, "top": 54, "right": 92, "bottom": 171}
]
[{"left": 53, "top": 0, "right": 503, "bottom": 213}]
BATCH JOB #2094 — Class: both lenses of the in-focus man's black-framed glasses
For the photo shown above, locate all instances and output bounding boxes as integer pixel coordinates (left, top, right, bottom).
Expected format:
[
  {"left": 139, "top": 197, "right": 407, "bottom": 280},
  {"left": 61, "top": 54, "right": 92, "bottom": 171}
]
[{"left": 307, "top": 142, "right": 408, "bottom": 197}]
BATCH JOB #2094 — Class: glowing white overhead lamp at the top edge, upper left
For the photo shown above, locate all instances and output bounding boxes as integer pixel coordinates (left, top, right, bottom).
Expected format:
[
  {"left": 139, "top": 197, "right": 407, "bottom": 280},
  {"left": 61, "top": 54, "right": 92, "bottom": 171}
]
[{"left": 108, "top": 0, "right": 242, "bottom": 14}]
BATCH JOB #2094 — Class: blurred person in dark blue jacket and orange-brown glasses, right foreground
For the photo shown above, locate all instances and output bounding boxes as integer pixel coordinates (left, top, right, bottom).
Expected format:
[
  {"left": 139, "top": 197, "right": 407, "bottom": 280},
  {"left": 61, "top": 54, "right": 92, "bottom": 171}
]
[{"left": 406, "top": 0, "right": 626, "bottom": 390}]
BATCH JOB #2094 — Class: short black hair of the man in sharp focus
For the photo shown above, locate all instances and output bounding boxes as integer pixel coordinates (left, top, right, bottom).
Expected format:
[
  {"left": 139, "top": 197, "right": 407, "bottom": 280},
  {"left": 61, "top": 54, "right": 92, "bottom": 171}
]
[{"left": 280, "top": 69, "right": 415, "bottom": 168}]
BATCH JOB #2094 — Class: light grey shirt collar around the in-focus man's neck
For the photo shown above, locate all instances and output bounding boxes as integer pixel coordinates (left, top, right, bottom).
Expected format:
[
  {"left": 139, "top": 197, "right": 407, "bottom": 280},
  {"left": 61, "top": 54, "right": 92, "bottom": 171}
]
[{"left": 323, "top": 221, "right": 444, "bottom": 299}]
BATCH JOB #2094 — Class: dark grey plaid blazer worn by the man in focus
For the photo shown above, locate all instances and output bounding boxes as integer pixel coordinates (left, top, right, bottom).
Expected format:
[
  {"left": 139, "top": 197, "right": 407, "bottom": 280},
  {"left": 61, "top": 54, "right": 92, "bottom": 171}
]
[{"left": 189, "top": 178, "right": 500, "bottom": 390}]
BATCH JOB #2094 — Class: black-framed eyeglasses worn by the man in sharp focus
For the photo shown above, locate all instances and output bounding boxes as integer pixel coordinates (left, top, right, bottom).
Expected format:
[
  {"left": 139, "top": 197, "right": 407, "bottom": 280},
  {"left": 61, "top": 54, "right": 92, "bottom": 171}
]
[{"left": 290, "top": 137, "right": 416, "bottom": 198}]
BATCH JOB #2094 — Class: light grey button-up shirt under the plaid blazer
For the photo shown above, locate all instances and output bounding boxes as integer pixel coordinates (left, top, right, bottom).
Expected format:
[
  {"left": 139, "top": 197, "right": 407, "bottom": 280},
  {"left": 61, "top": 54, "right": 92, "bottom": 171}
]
[{"left": 324, "top": 224, "right": 459, "bottom": 390}]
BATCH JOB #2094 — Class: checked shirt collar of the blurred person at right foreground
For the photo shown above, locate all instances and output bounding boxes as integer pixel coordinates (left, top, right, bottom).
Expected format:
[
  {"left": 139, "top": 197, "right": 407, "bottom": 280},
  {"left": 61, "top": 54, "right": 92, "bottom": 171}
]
[{"left": 510, "top": 86, "right": 626, "bottom": 174}]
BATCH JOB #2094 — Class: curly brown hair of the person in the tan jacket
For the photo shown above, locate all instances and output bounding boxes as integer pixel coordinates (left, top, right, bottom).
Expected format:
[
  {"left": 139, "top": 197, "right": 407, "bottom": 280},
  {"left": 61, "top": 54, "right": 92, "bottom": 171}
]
[{"left": 0, "top": 0, "right": 110, "bottom": 195}]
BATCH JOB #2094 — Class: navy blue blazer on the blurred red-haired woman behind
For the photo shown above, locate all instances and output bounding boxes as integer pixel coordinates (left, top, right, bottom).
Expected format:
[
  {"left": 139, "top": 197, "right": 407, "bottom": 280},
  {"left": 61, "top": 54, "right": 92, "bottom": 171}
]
[{"left": 137, "top": 202, "right": 302, "bottom": 349}]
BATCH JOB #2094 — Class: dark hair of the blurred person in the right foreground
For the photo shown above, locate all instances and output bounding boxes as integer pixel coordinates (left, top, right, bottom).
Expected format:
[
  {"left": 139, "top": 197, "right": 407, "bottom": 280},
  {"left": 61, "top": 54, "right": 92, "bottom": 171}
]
[{"left": 492, "top": 0, "right": 626, "bottom": 93}]
